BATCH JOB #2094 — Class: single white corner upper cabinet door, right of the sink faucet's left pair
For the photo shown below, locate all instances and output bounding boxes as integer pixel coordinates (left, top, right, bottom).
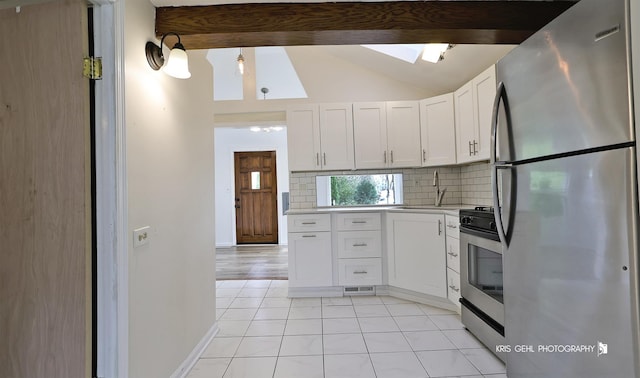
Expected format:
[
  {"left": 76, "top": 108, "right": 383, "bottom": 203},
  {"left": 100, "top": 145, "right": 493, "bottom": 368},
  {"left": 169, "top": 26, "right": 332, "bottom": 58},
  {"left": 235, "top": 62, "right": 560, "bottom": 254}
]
[{"left": 420, "top": 93, "right": 456, "bottom": 167}]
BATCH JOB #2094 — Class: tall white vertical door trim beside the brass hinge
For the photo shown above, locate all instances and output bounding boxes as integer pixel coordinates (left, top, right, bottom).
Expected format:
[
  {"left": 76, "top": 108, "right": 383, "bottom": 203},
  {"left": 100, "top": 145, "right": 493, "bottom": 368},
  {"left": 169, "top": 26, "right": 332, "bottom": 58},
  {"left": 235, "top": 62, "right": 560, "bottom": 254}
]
[{"left": 92, "top": 0, "right": 120, "bottom": 378}]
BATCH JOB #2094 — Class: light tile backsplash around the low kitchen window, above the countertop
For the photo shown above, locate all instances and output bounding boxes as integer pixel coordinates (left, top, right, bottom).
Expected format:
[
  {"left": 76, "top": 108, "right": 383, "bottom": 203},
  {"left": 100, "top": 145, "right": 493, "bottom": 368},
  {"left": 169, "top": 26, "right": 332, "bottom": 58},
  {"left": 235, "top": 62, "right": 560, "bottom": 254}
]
[{"left": 289, "top": 162, "right": 492, "bottom": 209}]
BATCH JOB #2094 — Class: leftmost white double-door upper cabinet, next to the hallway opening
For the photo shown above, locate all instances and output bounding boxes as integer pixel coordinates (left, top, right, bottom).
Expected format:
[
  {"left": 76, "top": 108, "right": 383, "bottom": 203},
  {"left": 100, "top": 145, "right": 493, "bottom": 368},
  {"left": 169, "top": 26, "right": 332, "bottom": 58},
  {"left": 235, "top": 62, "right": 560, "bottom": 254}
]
[{"left": 287, "top": 103, "right": 354, "bottom": 171}]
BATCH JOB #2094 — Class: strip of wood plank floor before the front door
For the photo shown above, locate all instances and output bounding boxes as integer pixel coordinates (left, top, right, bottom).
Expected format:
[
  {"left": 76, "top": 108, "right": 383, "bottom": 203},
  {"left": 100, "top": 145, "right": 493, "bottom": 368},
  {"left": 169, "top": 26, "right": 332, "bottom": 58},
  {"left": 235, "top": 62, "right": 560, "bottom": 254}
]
[{"left": 216, "top": 245, "right": 288, "bottom": 280}]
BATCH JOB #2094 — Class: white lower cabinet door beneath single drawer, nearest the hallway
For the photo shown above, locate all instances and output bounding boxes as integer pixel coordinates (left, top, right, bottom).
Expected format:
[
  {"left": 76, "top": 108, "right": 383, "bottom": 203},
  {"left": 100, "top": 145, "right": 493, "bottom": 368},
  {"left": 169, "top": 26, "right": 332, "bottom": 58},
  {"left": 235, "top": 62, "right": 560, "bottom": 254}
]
[{"left": 289, "top": 232, "right": 333, "bottom": 287}]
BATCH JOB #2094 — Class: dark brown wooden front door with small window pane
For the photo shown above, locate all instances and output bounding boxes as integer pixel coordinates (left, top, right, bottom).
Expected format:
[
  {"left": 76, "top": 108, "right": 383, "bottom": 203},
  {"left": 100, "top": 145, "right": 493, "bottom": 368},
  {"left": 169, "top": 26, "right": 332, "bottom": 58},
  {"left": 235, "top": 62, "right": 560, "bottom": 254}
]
[{"left": 234, "top": 151, "right": 278, "bottom": 244}]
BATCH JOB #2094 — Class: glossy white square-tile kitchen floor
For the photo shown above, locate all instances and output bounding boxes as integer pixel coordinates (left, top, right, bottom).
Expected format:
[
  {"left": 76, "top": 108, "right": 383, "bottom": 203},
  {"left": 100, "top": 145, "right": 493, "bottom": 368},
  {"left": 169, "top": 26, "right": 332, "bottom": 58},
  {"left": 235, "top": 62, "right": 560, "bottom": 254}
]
[{"left": 188, "top": 280, "right": 507, "bottom": 378}]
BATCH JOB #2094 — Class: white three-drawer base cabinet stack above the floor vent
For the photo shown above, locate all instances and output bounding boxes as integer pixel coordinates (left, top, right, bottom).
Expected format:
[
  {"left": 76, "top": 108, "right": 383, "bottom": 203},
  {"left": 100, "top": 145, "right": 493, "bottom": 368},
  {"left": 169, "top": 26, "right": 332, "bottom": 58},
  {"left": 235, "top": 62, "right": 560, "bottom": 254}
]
[{"left": 334, "top": 213, "right": 382, "bottom": 286}]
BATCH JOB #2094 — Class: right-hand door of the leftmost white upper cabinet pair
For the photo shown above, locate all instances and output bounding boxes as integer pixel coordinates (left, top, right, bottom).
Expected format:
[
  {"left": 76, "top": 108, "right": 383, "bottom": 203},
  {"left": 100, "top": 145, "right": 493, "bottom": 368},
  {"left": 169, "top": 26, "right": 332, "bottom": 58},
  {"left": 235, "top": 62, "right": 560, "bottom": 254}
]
[{"left": 320, "top": 104, "right": 355, "bottom": 170}]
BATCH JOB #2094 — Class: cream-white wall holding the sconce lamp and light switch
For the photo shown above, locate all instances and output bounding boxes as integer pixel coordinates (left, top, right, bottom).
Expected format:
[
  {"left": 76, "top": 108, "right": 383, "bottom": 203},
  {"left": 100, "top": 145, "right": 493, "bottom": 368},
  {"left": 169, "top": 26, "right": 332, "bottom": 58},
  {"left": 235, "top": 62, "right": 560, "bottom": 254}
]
[{"left": 124, "top": 0, "right": 216, "bottom": 378}]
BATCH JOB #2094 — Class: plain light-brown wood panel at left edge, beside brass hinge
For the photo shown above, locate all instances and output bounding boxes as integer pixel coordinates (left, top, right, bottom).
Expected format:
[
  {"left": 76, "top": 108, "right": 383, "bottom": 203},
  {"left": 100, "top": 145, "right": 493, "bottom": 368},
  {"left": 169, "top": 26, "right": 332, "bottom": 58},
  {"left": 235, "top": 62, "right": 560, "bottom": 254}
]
[{"left": 0, "top": 0, "right": 91, "bottom": 378}]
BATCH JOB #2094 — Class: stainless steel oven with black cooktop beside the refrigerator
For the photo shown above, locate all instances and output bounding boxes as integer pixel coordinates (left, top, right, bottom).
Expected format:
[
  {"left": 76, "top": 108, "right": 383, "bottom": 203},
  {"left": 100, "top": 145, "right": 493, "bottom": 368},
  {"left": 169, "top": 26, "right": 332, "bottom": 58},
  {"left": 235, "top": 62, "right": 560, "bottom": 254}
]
[{"left": 460, "top": 207, "right": 505, "bottom": 361}]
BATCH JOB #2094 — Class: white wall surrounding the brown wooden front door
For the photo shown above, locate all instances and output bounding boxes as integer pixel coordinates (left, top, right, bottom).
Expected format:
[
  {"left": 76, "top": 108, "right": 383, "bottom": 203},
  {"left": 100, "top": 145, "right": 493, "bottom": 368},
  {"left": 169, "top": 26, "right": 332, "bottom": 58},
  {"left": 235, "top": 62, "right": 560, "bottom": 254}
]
[{"left": 214, "top": 127, "right": 289, "bottom": 247}]
